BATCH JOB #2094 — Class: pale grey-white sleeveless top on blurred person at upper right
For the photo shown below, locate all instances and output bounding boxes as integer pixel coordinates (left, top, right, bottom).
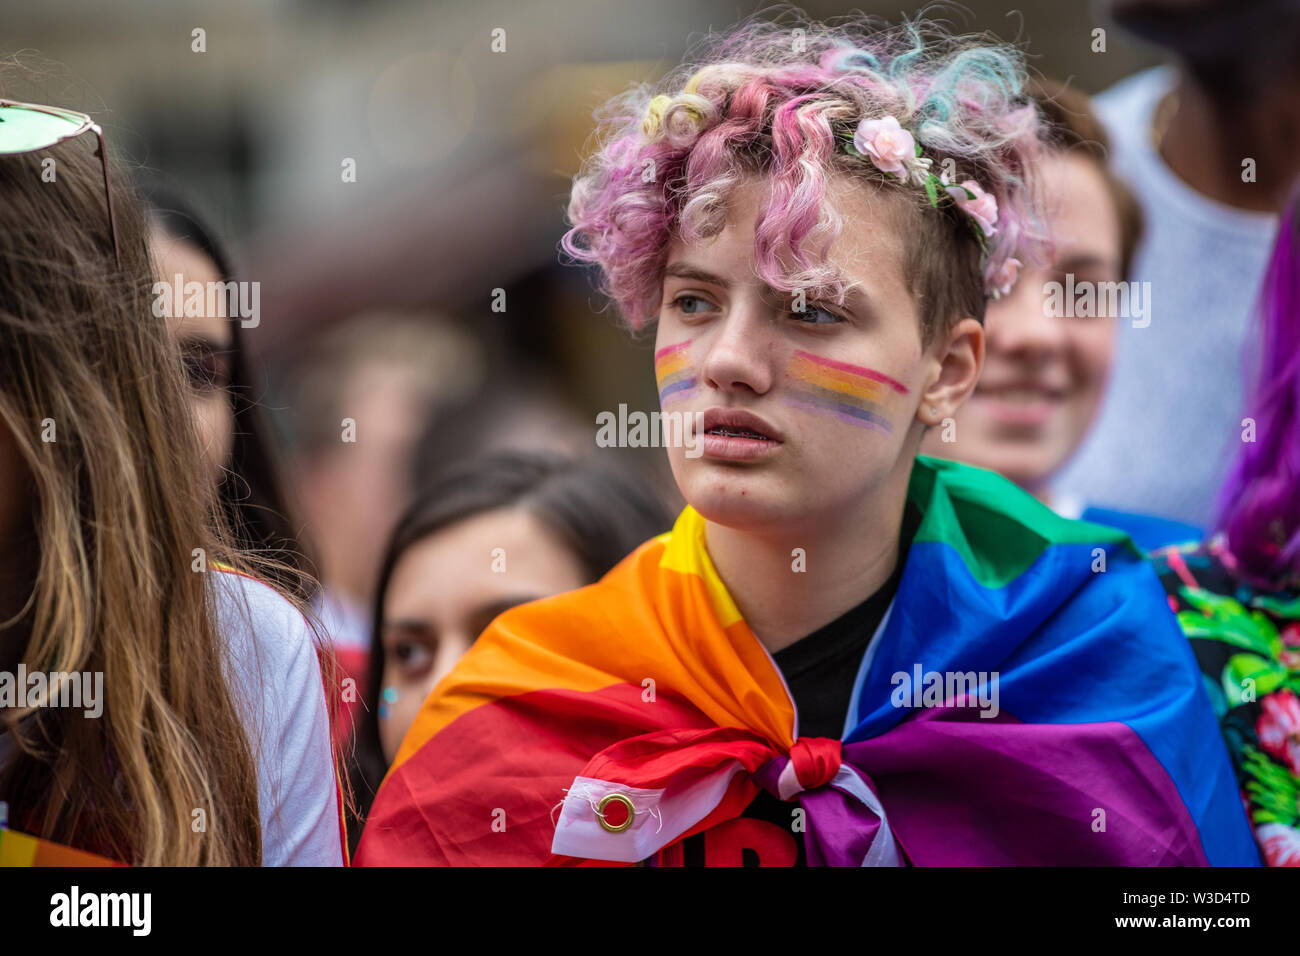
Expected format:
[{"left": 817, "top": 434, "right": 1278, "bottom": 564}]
[{"left": 1056, "top": 66, "right": 1278, "bottom": 528}]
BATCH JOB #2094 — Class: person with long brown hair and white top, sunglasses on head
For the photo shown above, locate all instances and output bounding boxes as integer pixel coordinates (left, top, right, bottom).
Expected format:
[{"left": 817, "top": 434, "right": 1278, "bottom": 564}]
[{"left": 0, "top": 89, "right": 346, "bottom": 865}]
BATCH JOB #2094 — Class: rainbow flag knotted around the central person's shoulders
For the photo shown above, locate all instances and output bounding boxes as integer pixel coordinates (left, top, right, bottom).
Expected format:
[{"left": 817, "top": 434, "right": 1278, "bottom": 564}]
[{"left": 356, "top": 458, "right": 1258, "bottom": 865}]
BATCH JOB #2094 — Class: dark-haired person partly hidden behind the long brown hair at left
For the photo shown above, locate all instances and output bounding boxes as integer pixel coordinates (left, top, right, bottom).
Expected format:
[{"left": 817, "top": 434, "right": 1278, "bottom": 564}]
[{"left": 143, "top": 186, "right": 313, "bottom": 601}]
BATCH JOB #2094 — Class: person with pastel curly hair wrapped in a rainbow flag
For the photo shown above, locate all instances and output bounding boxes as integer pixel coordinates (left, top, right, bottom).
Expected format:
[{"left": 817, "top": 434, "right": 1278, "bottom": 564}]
[{"left": 356, "top": 16, "right": 1258, "bottom": 866}]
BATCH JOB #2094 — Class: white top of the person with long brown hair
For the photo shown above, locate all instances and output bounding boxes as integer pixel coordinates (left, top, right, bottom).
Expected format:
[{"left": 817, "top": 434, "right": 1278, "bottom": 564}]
[{"left": 0, "top": 571, "right": 343, "bottom": 866}]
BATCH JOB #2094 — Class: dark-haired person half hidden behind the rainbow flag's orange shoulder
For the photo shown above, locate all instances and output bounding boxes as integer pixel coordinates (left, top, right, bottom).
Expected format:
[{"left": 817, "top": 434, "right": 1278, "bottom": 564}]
[{"left": 350, "top": 450, "right": 672, "bottom": 844}]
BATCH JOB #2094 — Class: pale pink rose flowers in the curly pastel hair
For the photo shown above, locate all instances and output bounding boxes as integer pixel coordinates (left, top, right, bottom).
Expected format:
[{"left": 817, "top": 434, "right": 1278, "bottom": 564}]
[{"left": 845, "top": 116, "right": 1022, "bottom": 299}]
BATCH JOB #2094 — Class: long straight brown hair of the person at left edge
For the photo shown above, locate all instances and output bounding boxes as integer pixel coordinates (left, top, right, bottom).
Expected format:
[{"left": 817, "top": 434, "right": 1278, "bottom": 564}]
[{"left": 0, "top": 85, "right": 280, "bottom": 865}]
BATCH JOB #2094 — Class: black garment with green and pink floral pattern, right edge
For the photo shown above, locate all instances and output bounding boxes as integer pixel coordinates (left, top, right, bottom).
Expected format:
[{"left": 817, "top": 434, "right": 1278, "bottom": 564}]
[{"left": 1151, "top": 536, "right": 1300, "bottom": 866}]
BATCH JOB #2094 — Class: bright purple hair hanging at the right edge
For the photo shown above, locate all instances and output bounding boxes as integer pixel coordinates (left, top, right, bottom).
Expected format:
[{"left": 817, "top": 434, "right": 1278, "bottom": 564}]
[{"left": 1219, "top": 193, "right": 1300, "bottom": 581}]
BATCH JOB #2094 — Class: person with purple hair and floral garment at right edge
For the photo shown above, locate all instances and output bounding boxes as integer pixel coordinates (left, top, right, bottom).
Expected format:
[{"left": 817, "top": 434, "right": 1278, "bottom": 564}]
[{"left": 1152, "top": 193, "right": 1300, "bottom": 866}]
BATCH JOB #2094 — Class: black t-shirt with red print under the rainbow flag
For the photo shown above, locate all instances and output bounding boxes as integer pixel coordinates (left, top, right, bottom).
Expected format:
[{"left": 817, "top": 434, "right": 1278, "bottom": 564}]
[{"left": 654, "top": 502, "right": 920, "bottom": 866}]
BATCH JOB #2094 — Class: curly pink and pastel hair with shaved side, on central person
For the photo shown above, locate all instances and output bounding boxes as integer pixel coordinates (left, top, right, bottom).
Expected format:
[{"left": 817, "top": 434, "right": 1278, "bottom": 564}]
[{"left": 560, "top": 13, "right": 1045, "bottom": 329}]
